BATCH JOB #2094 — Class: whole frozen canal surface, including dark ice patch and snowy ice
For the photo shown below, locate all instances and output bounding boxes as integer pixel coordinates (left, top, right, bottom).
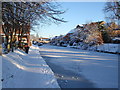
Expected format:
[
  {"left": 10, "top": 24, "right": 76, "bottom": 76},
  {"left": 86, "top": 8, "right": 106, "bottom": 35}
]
[{"left": 40, "top": 44, "right": 118, "bottom": 88}]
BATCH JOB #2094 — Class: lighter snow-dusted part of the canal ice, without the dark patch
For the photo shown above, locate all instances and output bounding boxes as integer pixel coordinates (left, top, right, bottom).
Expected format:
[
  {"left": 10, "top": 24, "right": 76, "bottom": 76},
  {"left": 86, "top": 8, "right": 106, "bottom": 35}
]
[{"left": 40, "top": 45, "right": 118, "bottom": 88}]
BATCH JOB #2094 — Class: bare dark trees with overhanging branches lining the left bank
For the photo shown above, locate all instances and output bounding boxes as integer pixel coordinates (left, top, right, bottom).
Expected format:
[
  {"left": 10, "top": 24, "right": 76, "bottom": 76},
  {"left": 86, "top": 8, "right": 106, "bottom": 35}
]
[{"left": 2, "top": 0, "right": 66, "bottom": 51}]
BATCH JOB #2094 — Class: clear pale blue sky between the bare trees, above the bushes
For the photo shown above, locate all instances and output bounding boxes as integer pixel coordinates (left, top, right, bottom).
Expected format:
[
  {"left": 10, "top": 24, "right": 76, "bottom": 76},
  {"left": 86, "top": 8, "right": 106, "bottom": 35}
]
[{"left": 31, "top": 2, "right": 105, "bottom": 37}]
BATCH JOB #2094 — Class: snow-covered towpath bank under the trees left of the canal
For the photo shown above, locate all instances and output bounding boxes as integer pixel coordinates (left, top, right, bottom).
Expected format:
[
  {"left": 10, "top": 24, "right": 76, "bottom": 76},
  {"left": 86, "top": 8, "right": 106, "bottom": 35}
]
[{"left": 2, "top": 46, "right": 59, "bottom": 88}]
